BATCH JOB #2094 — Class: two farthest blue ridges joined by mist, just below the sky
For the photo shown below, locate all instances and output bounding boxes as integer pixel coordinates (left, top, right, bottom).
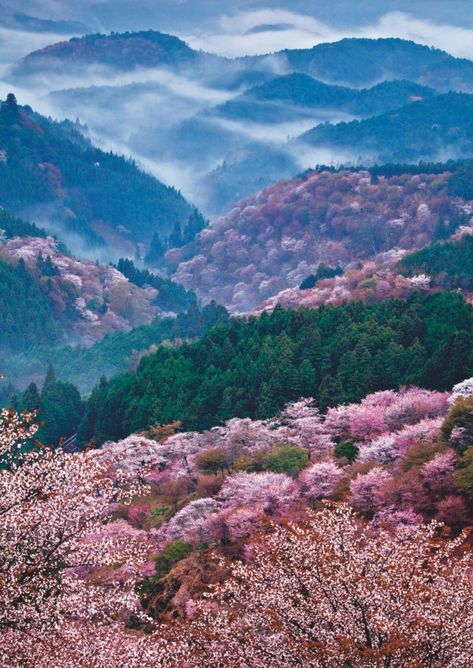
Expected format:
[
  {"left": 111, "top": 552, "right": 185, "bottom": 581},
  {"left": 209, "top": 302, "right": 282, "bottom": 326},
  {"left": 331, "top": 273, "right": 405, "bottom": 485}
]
[{"left": 13, "top": 30, "right": 473, "bottom": 91}]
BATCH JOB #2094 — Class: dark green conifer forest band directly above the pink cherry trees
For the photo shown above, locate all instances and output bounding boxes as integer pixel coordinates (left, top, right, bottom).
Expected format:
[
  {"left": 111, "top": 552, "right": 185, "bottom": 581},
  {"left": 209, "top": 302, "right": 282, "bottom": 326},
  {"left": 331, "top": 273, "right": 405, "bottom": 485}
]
[{"left": 83, "top": 293, "right": 473, "bottom": 443}]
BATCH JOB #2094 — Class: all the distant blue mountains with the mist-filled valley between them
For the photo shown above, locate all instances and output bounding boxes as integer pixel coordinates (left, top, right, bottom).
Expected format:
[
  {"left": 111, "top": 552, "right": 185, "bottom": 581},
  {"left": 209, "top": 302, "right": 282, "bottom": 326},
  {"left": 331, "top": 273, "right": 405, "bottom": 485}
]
[{"left": 9, "top": 31, "right": 473, "bottom": 217}]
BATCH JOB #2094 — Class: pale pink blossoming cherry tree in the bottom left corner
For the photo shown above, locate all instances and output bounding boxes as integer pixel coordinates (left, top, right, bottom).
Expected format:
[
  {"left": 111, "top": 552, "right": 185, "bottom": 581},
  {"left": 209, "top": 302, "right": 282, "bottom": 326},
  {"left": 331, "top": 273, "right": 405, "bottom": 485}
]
[{"left": 0, "top": 410, "right": 160, "bottom": 668}]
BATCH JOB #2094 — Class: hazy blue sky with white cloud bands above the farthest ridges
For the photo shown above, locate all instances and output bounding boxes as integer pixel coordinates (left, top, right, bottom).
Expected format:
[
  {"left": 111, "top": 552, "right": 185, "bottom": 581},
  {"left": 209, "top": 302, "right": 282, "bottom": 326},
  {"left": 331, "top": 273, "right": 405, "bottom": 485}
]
[{"left": 0, "top": 0, "right": 473, "bottom": 63}]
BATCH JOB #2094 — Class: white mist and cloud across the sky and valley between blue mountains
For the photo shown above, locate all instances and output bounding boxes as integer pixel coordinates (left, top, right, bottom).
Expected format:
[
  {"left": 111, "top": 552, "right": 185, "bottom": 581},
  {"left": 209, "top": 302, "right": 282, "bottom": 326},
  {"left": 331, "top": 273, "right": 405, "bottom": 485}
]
[{"left": 0, "top": 0, "right": 473, "bottom": 258}]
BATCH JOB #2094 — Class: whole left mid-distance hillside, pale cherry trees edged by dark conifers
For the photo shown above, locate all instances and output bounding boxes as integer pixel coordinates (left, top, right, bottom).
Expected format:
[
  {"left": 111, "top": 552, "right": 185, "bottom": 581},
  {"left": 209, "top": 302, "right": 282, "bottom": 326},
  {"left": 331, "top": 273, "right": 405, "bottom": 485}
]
[{"left": 0, "top": 211, "right": 208, "bottom": 392}]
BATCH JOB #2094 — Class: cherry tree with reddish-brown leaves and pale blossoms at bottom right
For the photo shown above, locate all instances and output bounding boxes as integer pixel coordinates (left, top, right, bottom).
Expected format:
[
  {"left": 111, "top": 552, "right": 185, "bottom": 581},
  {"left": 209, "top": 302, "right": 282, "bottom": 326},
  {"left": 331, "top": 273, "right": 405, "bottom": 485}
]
[{"left": 186, "top": 505, "right": 473, "bottom": 668}]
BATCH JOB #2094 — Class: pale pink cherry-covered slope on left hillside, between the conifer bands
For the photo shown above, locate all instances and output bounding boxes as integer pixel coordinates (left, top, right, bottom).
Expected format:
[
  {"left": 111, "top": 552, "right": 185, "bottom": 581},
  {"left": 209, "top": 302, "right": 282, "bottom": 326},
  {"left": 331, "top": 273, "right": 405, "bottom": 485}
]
[{"left": 0, "top": 237, "right": 160, "bottom": 352}]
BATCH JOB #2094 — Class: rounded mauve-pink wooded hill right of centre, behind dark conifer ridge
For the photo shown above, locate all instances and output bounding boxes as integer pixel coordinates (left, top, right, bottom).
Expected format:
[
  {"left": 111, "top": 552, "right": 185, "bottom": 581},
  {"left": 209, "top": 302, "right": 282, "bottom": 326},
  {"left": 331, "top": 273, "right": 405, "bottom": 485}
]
[{"left": 166, "top": 165, "right": 471, "bottom": 312}]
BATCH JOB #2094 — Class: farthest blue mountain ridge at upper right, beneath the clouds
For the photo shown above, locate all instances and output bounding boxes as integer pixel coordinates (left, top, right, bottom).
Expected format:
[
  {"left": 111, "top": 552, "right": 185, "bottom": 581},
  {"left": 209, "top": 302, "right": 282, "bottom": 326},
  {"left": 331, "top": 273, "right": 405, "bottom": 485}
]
[{"left": 251, "top": 38, "right": 473, "bottom": 92}]
